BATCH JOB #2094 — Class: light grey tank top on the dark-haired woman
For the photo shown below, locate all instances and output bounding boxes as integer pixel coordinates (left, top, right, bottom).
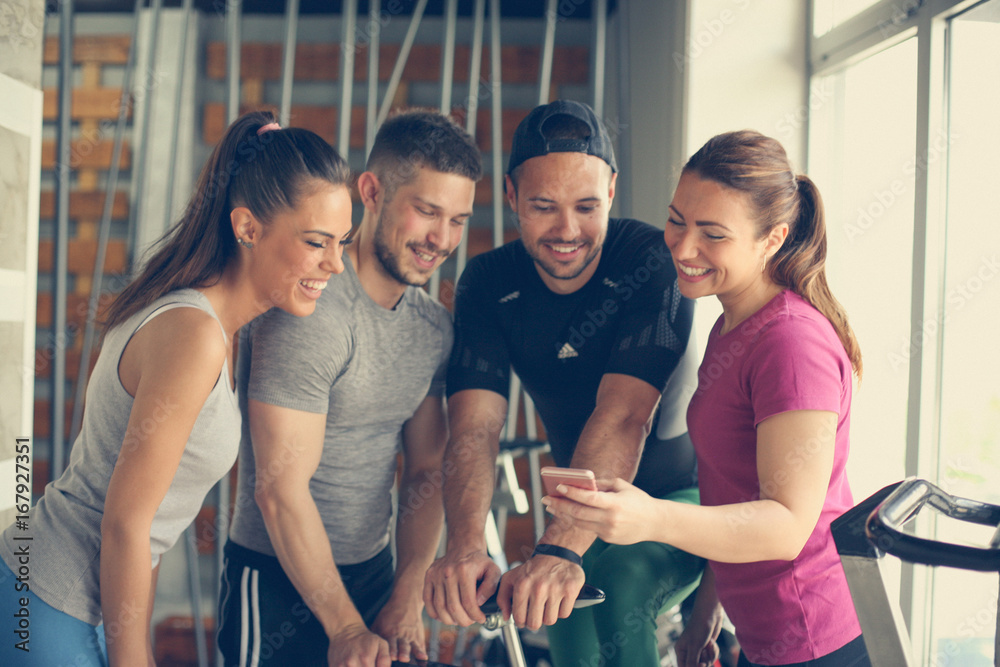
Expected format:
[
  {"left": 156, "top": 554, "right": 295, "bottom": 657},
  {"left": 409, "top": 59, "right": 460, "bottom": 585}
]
[{"left": 0, "top": 289, "right": 241, "bottom": 625}]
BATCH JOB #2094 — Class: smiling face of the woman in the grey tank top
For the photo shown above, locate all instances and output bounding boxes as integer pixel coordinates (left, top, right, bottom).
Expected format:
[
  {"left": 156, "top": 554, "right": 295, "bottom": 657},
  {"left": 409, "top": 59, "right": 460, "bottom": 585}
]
[{"left": 250, "top": 181, "right": 351, "bottom": 316}]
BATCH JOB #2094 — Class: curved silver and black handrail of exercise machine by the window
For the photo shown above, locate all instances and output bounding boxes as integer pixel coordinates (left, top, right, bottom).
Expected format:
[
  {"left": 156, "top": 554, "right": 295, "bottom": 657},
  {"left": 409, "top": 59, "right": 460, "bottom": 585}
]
[{"left": 865, "top": 477, "right": 1000, "bottom": 572}]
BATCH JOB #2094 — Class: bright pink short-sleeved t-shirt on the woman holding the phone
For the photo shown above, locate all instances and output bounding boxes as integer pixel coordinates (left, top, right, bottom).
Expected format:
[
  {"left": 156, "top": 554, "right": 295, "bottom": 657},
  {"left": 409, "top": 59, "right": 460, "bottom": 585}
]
[{"left": 688, "top": 290, "right": 861, "bottom": 665}]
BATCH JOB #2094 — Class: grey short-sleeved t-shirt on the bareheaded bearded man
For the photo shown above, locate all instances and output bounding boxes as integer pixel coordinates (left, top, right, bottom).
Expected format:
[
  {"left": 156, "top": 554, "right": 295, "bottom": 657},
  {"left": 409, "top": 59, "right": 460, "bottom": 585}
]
[{"left": 230, "top": 254, "right": 452, "bottom": 565}]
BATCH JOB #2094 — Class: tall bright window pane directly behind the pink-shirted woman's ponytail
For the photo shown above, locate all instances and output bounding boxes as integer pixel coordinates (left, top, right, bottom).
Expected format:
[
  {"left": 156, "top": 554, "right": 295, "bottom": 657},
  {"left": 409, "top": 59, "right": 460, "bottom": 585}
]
[{"left": 809, "top": 39, "right": 917, "bottom": 500}]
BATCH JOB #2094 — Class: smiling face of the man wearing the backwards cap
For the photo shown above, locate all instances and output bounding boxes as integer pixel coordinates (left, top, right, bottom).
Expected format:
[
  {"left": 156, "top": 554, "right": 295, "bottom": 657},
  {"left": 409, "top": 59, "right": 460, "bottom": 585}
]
[{"left": 507, "top": 153, "right": 618, "bottom": 294}]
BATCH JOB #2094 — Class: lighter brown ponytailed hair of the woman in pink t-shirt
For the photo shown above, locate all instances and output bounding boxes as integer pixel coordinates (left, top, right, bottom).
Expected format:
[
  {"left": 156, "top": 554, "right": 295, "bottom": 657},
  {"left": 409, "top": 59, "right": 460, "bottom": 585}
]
[{"left": 684, "top": 130, "right": 862, "bottom": 379}]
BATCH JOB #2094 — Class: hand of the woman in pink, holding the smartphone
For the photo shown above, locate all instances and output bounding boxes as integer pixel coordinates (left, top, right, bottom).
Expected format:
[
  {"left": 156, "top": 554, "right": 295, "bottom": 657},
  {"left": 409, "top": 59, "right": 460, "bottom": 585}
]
[{"left": 542, "top": 479, "right": 656, "bottom": 544}]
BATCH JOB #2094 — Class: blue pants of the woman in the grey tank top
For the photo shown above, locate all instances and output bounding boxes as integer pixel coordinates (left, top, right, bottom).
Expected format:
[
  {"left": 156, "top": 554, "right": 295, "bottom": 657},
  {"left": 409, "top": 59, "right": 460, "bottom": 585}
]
[{"left": 0, "top": 559, "right": 108, "bottom": 667}]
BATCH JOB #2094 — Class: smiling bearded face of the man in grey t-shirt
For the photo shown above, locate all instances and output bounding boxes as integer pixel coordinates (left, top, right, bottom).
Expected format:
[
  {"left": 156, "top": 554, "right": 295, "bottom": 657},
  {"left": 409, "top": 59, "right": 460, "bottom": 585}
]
[{"left": 373, "top": 167, "right": 475, "bottom": 286}]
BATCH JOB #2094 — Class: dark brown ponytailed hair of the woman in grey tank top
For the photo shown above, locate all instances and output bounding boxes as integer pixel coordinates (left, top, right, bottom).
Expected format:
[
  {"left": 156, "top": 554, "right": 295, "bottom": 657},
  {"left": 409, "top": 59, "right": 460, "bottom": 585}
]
[{"left": 103, "top": 111, "right": 350, "bottom": 329}]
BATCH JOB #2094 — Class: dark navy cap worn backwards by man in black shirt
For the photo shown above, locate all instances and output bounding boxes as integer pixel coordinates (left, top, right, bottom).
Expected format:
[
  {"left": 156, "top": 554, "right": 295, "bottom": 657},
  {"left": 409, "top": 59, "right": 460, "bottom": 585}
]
[{"left": 507, "top": 100, "right": 618, "bottom": 174}]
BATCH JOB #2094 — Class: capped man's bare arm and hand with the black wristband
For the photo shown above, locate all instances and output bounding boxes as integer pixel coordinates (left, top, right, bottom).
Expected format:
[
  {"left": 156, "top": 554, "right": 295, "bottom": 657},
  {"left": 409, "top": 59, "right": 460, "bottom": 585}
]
[{"left": 498, "top": 373, "right": 660, "bottom": 630}]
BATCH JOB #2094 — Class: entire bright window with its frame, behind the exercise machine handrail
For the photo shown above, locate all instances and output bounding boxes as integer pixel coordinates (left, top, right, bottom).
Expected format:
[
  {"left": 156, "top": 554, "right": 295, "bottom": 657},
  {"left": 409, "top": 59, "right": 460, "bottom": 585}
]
[{"left": 808, "top": 0, "right": 1000, "bottom": 666}]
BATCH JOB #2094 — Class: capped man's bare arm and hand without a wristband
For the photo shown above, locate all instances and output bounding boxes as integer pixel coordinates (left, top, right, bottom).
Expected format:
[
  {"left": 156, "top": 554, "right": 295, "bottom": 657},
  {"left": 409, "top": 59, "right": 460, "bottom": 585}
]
[{"left": 424, "top": 389, "right": 507, "bottom": 626}]
